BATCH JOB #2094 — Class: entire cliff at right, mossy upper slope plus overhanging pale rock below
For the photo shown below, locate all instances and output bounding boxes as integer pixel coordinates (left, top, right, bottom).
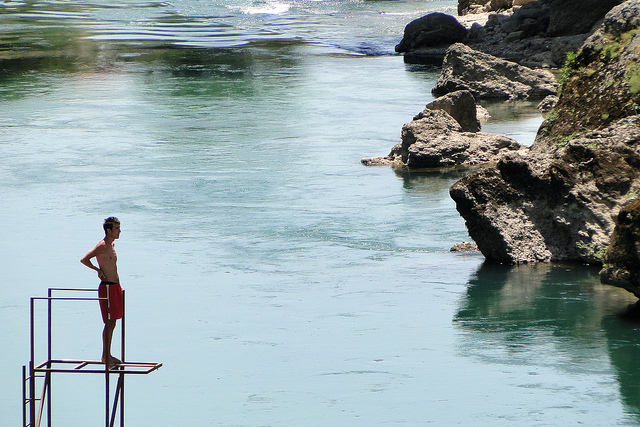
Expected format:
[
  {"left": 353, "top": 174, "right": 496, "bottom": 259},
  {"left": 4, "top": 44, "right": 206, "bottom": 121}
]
[{"left": 451, "top": 0, "right": 640, "bottom": 263}]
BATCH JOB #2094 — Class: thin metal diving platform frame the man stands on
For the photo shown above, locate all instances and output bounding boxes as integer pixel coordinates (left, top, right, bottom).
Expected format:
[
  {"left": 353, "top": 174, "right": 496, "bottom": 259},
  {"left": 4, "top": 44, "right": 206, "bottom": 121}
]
[{"left": 22, "top": 288, "right": 162, "bottom": 427}]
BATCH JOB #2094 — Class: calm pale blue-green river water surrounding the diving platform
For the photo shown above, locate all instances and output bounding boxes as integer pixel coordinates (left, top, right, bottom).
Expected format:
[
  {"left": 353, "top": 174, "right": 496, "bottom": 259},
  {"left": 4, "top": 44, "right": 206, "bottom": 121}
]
[{"left": 0, "top": 0, "right": 640, "bottom": 427}]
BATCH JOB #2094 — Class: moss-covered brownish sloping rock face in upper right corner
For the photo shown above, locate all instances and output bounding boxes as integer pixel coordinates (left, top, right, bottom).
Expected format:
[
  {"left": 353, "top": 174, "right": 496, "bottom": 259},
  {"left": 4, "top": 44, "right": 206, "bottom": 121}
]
[{"left": 534, "top": 2, "right": 640, "bottom": 147}]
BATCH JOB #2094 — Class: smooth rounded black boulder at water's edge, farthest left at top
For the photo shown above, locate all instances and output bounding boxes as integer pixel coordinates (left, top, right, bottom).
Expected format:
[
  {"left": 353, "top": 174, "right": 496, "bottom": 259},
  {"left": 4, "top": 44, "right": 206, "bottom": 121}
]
[{"left": 396, "top": 12, "right": 467, "bottom": 52}]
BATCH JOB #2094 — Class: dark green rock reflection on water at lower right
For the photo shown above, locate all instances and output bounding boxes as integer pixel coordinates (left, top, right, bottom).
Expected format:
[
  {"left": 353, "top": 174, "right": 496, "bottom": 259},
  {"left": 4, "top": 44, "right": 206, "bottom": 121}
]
[{"left": 454, "top": 263, "right": 640, "bottom": 422}]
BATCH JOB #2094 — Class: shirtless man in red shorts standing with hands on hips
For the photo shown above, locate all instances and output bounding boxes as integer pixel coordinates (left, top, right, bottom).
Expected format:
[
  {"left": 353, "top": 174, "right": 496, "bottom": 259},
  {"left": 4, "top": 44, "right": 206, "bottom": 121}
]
[{"left": 80, "top": 216, "right": 124, "bottom": 366}]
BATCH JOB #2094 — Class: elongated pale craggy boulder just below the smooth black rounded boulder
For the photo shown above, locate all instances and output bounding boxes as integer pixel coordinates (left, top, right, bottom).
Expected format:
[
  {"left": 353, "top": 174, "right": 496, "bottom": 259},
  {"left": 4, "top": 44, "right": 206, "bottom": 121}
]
[{"left": 432, "top": 43, "right": 558, "bottom": 100}]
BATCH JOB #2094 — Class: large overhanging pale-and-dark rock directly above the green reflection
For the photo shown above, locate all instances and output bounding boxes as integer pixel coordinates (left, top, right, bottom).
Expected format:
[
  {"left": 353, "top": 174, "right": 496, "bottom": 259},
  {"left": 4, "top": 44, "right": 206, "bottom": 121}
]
[{"left": 450, "top": 116, "right": 640, "bottom": 263}]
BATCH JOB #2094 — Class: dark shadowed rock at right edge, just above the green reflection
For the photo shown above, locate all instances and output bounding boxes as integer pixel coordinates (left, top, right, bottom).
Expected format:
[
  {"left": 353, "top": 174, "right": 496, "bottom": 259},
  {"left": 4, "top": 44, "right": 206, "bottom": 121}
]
[{"left": 600, "top": 199, "right": 640, "bottom": 298}]
